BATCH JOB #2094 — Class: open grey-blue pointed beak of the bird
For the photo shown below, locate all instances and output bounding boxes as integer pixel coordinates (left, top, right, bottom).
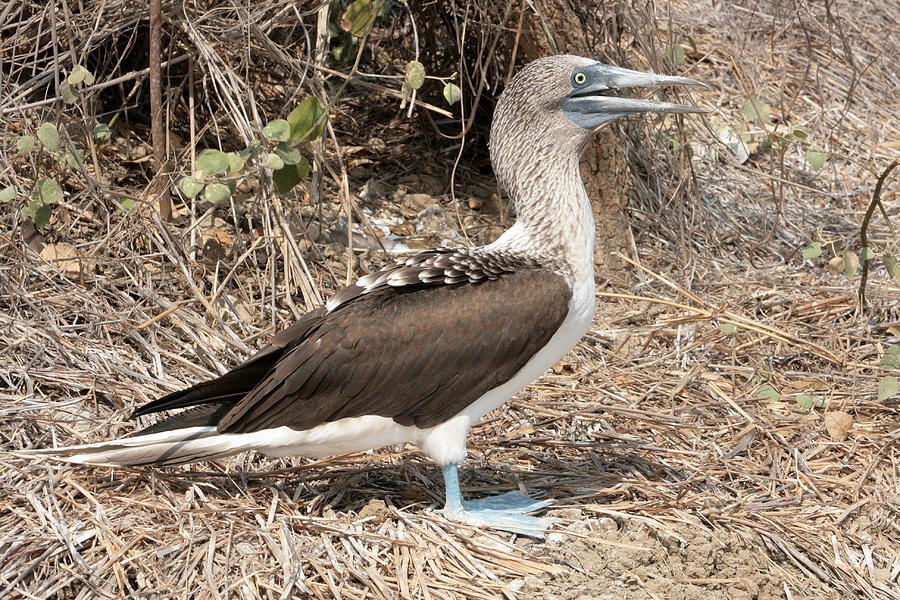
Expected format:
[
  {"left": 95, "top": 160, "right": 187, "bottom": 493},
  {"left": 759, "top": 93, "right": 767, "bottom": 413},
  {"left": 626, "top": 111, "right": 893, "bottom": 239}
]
[{"left": 562, "top": 63, "right": 709, "bottom": 129}]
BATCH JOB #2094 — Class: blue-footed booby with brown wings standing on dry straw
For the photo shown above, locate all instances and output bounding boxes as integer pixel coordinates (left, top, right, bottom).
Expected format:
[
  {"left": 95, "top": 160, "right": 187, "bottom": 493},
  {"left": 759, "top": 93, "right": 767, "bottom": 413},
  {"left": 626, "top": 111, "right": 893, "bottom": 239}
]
[{"left": 31, "top": 56, "right": 703, "bottom": 536}]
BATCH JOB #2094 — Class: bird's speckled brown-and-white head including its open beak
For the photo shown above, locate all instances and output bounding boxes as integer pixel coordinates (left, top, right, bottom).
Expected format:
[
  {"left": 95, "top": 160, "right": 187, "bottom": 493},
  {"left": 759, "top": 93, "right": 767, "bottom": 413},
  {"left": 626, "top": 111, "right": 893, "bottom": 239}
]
[{"left": 490, "top": 55, "right": 708, "bottom": 190}]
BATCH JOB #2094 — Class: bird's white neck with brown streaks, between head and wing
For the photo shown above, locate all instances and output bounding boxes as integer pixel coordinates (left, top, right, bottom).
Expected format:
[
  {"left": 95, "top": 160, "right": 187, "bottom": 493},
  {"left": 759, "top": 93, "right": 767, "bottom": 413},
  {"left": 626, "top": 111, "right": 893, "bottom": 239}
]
[{"left": 492, "top": 152, "right": 595, "bottom": 286}]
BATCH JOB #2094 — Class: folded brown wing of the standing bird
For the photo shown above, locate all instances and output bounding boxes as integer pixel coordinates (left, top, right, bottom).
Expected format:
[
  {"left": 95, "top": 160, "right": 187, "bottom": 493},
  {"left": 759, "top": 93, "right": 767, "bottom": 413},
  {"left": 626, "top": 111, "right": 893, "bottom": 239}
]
[{"left": 218, "top": 269, "right": 571, "bottom": 433}]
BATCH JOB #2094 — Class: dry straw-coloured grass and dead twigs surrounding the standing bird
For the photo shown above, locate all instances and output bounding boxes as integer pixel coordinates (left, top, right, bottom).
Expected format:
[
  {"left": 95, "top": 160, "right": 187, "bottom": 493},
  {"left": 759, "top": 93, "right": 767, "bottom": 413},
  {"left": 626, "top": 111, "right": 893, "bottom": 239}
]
[{"left": 0, "top": 0, "right": 900, "bottom": 599}]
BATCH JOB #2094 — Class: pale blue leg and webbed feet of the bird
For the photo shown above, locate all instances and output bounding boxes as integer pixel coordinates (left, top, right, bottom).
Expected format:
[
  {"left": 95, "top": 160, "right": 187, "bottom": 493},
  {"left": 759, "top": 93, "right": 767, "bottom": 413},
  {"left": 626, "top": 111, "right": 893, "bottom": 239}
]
[{"left": 441, "top": 463, "right": 555, "bottom": 538}]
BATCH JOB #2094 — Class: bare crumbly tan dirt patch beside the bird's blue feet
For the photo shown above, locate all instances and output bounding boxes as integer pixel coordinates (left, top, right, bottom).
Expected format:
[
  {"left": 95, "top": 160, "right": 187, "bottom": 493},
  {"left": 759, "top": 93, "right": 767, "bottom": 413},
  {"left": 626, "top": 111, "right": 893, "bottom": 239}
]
[{"left": 521, "top": 509, "right": 804, "bottom": 600}]
